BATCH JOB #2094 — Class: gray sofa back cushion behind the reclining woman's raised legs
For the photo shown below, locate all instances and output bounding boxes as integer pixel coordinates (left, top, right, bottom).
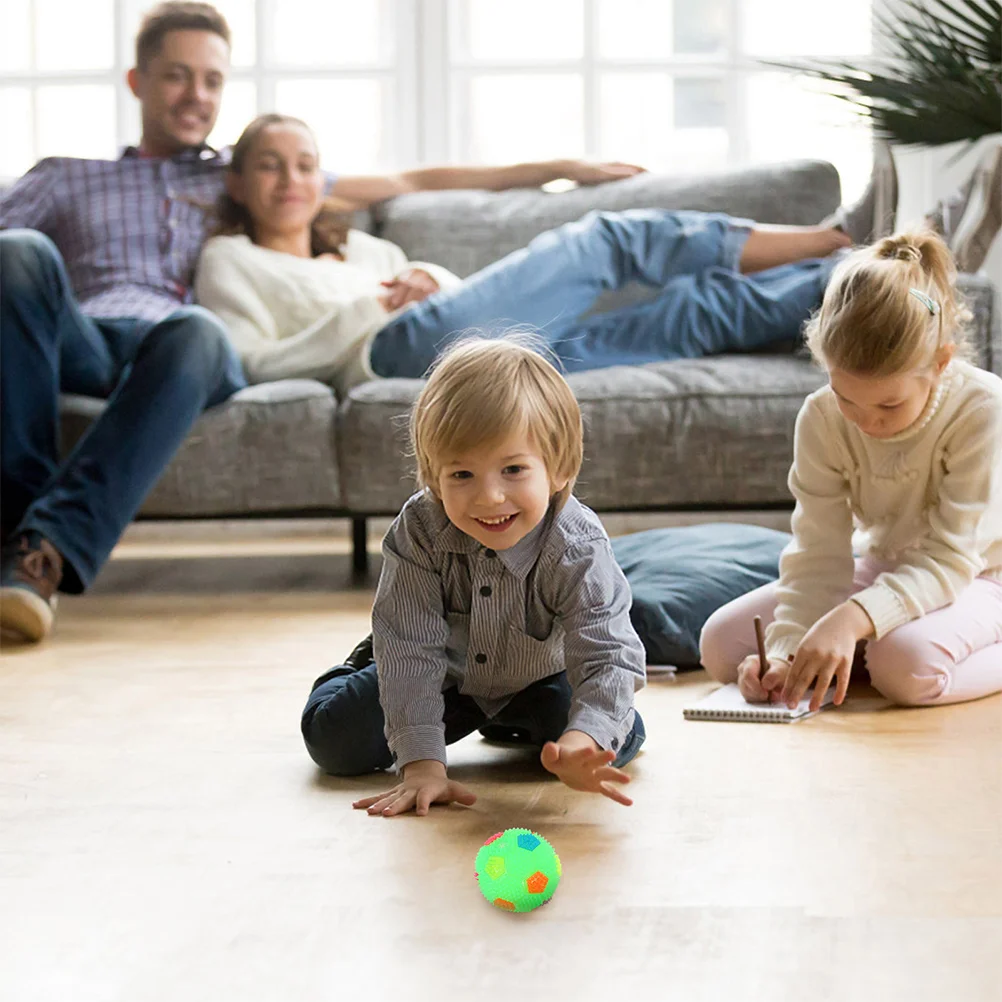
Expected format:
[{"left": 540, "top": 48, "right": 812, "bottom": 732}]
[{"left": 373, "top": 160, "right": 841, "bottom": 282}]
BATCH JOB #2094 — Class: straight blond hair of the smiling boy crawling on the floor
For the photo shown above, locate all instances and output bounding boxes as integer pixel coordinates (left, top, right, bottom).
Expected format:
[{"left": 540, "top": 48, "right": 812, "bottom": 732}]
[{"left": 411, "top": 334, "right": 584, "bottom": 507}]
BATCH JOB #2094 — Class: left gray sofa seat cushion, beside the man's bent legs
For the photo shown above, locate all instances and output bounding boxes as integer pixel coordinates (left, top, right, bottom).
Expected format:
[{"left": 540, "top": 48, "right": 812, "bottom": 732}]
[{"left": 61, "top": 380, "right": 341, "bottom": 518}]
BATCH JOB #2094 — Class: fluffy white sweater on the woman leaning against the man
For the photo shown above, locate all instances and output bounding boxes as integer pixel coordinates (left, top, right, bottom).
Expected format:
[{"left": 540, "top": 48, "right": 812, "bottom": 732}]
[{"left": 194, "top": 229, "right": 460, "bottom": 392}]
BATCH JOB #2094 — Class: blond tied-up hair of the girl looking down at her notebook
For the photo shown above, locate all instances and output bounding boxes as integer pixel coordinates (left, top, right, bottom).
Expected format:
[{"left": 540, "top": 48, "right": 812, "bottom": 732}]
[{"left": 805, "top": 229, "right": 972, "bottom": 377}]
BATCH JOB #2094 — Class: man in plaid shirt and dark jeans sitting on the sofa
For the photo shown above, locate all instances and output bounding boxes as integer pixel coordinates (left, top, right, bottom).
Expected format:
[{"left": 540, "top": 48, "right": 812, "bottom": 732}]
[{"left": 0, "top": 0, "right": 639, "bottom": 641}]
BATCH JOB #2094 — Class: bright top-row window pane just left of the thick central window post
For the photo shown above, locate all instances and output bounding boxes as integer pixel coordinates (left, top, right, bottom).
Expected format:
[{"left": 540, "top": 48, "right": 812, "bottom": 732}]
[{"left": 271, "top": 0, "right": 389, "bottom": 68}]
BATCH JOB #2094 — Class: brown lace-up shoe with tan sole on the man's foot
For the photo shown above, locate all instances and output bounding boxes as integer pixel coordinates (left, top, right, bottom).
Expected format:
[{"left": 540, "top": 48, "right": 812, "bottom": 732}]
[{"left": 0, "top": 531, "right": 63, "bottom": 640}]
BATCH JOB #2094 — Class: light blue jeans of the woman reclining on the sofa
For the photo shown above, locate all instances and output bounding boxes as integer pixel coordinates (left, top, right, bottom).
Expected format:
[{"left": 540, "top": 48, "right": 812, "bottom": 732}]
[{"left": 370, "top": 208, "right": 836, "bottom": 378}]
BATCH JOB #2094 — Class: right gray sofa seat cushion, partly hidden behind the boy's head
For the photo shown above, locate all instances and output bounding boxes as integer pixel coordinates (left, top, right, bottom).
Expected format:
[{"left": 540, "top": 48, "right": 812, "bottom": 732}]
[{"left": 338, "top": 355, "right": 823, "bottom": 514}]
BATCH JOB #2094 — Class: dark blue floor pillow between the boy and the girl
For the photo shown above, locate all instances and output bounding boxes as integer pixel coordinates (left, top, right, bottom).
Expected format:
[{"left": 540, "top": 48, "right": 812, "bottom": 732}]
[{"left": 612, "top": 522, "right": 791, "bottom": 667}]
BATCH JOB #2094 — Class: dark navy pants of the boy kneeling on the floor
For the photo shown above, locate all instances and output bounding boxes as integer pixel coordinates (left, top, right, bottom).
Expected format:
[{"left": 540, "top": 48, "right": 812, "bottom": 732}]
[{"left": 301, "top": 659, "right": 646, "bottom": 776}]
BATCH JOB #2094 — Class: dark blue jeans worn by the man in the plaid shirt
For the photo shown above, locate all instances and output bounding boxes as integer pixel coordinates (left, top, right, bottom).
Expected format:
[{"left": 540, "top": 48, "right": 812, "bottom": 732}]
[{"left": 0, "top": 229, "right": 245, "bottom": 591}]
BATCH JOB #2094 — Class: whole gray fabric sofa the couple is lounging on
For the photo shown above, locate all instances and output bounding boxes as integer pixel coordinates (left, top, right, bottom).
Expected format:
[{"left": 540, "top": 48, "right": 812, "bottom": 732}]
[{"left": 56, "top": 161, "right": 1002, "bottom": 571}]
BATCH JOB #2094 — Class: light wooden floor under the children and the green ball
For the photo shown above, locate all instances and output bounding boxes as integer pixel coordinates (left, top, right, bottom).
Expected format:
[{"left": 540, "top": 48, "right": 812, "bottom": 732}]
[{"left": 0, "top": 529, "right": 1002, "bottom": 1002}]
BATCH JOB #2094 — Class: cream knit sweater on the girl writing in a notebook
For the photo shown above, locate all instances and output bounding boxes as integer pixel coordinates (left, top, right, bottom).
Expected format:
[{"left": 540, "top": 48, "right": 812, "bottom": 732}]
[{"left": 767, "top": 362, "right": 1002, "bottom": 658}]
